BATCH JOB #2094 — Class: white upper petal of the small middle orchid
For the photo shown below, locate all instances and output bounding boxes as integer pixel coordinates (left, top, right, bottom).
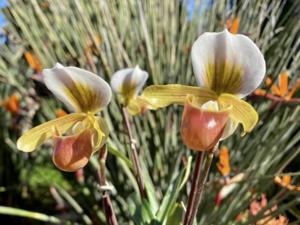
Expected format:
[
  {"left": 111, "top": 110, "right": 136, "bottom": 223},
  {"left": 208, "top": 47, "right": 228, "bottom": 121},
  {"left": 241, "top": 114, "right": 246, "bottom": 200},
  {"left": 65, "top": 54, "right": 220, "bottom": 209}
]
[{"left": 110, "top": 66, "right": 148, "bottom": 105}]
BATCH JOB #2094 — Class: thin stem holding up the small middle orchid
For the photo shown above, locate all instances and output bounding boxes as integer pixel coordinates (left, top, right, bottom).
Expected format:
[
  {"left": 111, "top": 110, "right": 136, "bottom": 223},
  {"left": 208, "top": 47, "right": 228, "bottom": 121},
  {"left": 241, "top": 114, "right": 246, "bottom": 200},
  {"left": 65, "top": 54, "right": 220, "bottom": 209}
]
[{"left": 122, "top": 107, "right": 146, "bottom": 198}]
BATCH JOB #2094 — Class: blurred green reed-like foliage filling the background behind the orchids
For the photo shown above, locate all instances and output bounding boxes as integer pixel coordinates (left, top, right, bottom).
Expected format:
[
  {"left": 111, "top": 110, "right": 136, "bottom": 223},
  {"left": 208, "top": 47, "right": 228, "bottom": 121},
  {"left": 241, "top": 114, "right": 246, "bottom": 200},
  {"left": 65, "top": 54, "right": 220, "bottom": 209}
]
[{"left": 0, "top": 0, "right": 300, "bottom": 225}]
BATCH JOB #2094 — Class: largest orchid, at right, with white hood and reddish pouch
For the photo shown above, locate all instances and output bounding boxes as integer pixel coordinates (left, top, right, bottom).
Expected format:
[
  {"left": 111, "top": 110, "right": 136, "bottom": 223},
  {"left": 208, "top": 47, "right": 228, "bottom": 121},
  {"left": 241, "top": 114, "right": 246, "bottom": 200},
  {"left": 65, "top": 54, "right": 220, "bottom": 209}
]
[{"left": 141, "top": 30, "right": 266, "bottom": 151}]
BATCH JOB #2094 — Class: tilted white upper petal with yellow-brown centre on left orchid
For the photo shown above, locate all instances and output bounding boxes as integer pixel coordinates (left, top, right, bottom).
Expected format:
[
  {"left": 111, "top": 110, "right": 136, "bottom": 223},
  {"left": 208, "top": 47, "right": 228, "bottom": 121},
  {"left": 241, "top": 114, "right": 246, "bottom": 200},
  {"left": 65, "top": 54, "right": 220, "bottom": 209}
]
[{"left": 43, "top": 63, "right": 111, "bottom": 113}]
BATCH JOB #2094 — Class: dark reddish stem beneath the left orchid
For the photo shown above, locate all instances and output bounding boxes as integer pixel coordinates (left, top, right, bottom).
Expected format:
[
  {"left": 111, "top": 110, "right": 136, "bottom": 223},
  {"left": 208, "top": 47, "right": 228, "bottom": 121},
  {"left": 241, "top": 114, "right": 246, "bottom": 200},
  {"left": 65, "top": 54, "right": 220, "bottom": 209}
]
[{"left": 98, "top": 145, "right": 118, "bottom": 225}]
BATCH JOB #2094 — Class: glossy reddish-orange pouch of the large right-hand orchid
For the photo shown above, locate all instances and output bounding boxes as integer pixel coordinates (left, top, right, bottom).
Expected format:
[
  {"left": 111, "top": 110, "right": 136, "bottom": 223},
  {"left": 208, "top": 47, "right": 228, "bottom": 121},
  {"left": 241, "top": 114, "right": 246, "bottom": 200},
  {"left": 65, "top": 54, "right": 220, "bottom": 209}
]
[{"left": 181, "top": 96, "right": 231, "bottom": 151}]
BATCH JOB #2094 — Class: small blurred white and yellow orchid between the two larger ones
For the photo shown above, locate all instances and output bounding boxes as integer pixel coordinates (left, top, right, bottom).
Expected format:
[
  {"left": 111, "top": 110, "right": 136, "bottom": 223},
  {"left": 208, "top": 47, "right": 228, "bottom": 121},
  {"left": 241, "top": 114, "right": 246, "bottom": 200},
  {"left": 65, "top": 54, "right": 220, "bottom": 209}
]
[{"left": 110, "top": 66, "right": 148, "bottom": 115}]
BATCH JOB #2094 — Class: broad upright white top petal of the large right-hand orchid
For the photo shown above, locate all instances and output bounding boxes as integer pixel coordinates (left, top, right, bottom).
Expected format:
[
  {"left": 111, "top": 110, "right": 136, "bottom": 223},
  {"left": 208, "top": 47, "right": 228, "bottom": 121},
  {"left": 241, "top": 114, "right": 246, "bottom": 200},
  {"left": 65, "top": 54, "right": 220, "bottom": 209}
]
[{"left": 191, "top": 30, "right": 266, "bottom": 97}]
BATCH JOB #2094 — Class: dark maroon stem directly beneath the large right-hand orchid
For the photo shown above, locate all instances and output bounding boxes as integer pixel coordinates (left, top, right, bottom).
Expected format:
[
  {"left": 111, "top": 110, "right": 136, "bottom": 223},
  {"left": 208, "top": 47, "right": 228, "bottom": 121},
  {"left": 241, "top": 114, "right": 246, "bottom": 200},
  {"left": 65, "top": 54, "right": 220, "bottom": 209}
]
[{"left": 183, "top": 149, "right": 213, "bottom": 225}]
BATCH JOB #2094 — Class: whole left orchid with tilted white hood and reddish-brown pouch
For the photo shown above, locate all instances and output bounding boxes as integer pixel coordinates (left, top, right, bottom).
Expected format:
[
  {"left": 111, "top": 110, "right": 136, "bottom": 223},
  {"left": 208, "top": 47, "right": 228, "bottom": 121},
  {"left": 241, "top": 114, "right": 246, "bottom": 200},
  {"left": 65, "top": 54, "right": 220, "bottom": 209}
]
[{"left": 17, "top": 64, "right": 111, "bottom": 171}]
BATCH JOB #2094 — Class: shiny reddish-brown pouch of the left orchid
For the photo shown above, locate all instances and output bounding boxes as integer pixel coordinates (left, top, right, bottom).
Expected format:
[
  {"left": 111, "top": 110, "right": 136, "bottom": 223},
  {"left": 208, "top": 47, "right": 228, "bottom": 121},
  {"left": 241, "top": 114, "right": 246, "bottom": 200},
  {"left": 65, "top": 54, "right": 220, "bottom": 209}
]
[{"left": 52, "top": 129, "right": 93, "bottom": 172}]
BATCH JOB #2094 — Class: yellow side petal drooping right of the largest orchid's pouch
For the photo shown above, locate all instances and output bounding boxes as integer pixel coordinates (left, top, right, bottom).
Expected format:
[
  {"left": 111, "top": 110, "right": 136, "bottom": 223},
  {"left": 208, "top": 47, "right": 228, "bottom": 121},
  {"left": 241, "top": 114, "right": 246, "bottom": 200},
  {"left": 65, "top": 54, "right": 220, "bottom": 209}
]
[{"left": 218, "top": 94, "right": 258, "bottom": 133}]
